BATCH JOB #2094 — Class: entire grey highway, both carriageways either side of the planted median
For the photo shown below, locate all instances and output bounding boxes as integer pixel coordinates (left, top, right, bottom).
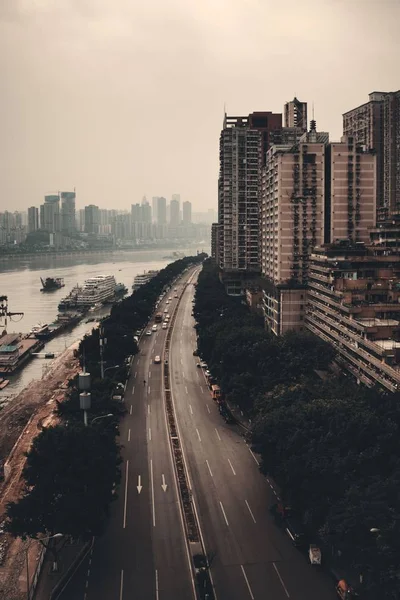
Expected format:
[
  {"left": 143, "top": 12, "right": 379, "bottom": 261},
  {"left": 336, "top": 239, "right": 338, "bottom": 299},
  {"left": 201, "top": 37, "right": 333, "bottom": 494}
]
[{"left": 60, "top": 273, "right": 336, "bottom": 600}]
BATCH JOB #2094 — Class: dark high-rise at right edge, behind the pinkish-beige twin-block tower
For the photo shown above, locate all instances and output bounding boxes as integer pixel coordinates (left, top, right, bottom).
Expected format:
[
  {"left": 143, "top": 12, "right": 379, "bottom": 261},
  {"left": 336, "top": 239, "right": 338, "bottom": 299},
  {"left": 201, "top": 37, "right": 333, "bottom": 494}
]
[{"left": 343, "top": 91, "right": 400, "bottom": 221}]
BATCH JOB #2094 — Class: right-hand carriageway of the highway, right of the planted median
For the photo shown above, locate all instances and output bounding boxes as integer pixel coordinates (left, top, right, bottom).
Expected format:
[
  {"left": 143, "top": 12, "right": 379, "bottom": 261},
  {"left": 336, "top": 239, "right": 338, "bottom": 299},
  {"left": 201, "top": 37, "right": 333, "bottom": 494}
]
[{"left": 170, "top": 276, "right": 336, "bottom": 600}]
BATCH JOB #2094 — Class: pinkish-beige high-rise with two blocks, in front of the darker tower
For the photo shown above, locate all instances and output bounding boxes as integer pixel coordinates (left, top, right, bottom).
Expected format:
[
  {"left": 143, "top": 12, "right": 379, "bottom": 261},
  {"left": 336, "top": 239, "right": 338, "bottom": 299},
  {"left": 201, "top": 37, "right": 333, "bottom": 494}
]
[{"left": 261, "top": 121, "right": 376, "bottom": 335}]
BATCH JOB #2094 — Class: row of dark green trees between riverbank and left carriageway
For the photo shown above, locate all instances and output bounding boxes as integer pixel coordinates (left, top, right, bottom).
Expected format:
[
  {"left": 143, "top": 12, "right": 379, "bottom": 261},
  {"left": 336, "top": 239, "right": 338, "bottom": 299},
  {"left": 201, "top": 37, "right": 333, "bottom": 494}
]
[{"left": 6, "top": 255, "right": 205, "bottom": 540}]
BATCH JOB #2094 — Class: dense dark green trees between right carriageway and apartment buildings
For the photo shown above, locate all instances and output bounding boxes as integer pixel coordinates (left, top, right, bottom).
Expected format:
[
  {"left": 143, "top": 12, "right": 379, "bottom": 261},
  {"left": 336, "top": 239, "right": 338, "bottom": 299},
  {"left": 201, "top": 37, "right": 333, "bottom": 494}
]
[{"left": 195, "top": 262, "right": 400, "bottom": 599}]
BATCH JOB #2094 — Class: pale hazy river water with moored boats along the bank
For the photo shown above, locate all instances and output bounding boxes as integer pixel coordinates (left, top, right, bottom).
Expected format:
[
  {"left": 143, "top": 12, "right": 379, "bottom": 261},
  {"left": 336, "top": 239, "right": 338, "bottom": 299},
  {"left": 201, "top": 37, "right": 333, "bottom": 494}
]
[{"left": 0, "top": 249, "right": 200, "bottom": 404}]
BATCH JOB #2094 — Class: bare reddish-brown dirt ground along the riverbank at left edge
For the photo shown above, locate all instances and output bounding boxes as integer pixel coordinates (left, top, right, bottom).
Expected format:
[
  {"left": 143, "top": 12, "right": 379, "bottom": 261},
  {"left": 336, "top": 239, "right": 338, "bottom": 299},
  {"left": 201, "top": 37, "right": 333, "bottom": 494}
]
[{"left": 0, "top": 344, "right": 79, "bottom": 600}]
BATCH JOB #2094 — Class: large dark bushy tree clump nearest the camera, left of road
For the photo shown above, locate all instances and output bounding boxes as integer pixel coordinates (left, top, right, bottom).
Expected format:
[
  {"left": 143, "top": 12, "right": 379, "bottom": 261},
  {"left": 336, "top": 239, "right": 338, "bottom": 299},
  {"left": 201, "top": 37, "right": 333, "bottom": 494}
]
[{"left": 7, "top": 423, "right": 121, "bottom": 539}]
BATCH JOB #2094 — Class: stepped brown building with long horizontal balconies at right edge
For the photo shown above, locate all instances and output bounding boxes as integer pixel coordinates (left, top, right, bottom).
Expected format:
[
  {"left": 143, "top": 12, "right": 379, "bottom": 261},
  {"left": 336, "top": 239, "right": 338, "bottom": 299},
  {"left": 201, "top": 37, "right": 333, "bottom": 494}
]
[{"left": 305, "top": 242, "right": 400, "bottom": 392}]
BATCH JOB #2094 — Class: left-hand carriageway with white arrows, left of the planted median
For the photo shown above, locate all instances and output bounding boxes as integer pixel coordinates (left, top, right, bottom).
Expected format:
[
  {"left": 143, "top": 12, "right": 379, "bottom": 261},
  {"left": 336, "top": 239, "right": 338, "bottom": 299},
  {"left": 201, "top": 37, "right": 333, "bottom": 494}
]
[{"left": 61, "top": 276, "right": 195, "bottom": 600}]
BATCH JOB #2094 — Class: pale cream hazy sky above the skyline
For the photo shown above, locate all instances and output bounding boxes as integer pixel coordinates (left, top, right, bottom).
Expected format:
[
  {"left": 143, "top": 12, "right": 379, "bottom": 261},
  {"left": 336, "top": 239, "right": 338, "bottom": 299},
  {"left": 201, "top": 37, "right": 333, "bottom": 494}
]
[{"left": 0, "top": 0, "right": 400, "bottom": 210}]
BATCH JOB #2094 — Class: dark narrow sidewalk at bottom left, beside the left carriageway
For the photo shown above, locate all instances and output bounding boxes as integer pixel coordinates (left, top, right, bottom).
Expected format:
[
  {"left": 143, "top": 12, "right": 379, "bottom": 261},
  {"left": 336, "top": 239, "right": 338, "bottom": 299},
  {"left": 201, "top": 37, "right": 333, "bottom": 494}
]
[{"left": 33, "top": 542, "right": 91, "bottom": 600}]
